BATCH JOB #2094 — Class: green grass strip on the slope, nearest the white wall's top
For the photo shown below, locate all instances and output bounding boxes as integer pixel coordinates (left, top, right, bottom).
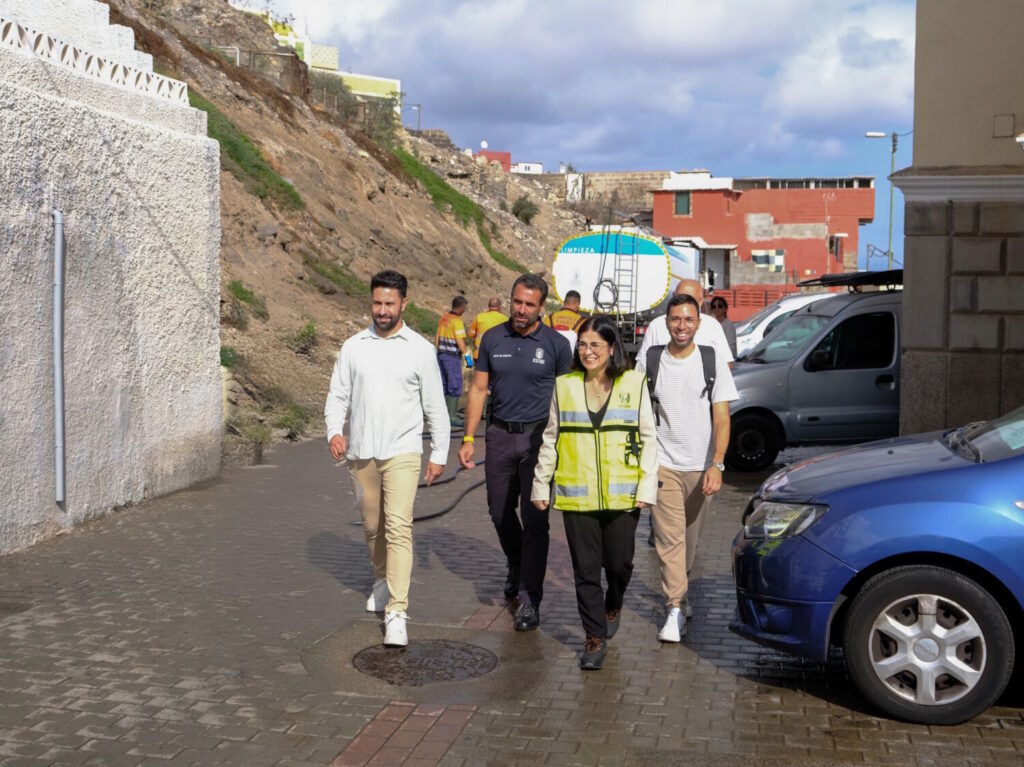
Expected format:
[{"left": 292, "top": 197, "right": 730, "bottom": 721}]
[{"left": 188, "top": 88, "right": 305, "bottom": 210}]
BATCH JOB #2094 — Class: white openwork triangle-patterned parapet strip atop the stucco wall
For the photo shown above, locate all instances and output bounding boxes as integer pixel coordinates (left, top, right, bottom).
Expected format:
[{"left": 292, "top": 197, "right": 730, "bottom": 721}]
[{"left": 0, "top": 17, "right": 188, "bottom": 106}]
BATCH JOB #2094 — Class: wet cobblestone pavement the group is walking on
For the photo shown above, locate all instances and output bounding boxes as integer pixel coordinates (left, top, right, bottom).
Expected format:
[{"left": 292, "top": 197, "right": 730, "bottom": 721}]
[{"left": 0, "top": 434, "right": 1024, "bottom": 767}]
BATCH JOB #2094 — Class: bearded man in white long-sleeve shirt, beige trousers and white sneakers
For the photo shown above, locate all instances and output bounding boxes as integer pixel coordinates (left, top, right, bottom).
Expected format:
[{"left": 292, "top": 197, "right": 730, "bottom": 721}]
[{"left": 324, "top": 269, "right": 452, "bottom": 647}]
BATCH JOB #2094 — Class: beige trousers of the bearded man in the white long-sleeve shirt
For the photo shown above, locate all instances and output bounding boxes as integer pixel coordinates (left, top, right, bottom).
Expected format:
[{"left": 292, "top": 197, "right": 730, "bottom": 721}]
[{"left": 348, "top": 453, "right": 421, "bottom": 612}]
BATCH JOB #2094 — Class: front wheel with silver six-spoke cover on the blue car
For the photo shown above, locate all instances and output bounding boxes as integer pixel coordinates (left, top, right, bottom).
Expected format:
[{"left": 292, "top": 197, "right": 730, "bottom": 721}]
[{"left": 843, "top": 565, "right": 1014, "bottom": 724}]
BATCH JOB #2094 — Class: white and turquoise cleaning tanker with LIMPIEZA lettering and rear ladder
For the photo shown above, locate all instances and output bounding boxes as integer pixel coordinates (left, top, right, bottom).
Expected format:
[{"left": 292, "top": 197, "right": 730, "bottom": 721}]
[{"left": 551, "top": 221, "right": 699, "bottom": 355}]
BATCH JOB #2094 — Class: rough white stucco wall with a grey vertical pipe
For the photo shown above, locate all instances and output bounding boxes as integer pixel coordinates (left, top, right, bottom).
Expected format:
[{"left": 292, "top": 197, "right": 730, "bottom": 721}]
[{"left": 0, "top": 8, "right": 221, "bottom": 553}]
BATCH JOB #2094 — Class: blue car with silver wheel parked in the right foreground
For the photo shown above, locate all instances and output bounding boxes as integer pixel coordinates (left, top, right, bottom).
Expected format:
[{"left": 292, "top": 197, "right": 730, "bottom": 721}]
[{"left": 729, "top": 408, "right": 1024, "bottom": 724}]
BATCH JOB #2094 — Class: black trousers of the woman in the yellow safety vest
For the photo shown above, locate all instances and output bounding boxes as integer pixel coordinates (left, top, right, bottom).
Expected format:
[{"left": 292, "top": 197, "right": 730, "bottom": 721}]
[{"left": 562, "top": 509, "right": 640, "bottom": 639}]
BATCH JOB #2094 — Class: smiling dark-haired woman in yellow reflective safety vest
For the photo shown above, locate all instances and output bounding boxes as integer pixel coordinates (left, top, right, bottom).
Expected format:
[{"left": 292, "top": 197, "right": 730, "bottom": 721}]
[{"left": 530, "top": 315, "right": 657, "bottom": 670}]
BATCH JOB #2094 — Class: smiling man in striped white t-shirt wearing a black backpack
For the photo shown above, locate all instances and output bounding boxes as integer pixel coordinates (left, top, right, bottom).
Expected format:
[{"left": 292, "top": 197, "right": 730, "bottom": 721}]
[{"left": 637, "top": 294, "right": 738, "bottom": 642}]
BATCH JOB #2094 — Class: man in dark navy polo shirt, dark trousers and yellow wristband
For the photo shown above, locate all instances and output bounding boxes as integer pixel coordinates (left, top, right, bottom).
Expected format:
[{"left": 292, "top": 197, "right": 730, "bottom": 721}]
[{"left": 459, "top": 274, "right": 572, "bottom": 631}]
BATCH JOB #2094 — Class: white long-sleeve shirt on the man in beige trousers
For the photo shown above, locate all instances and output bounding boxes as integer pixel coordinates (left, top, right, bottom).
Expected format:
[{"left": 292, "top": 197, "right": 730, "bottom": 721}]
[{"left": 324, "top": 324, "right": 452, "bottom": 466}]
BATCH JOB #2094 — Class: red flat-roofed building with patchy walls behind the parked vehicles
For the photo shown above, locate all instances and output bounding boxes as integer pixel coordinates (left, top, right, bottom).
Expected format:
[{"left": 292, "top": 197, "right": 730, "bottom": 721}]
[{"left": 652, "top": 171, "right": 874, "bottom": 319}]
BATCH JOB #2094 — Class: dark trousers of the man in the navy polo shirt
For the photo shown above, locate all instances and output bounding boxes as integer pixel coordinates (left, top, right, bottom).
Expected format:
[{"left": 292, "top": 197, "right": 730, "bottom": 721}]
[{"left": 483, "top": 423, "right": 549, "bottom": 607}]
